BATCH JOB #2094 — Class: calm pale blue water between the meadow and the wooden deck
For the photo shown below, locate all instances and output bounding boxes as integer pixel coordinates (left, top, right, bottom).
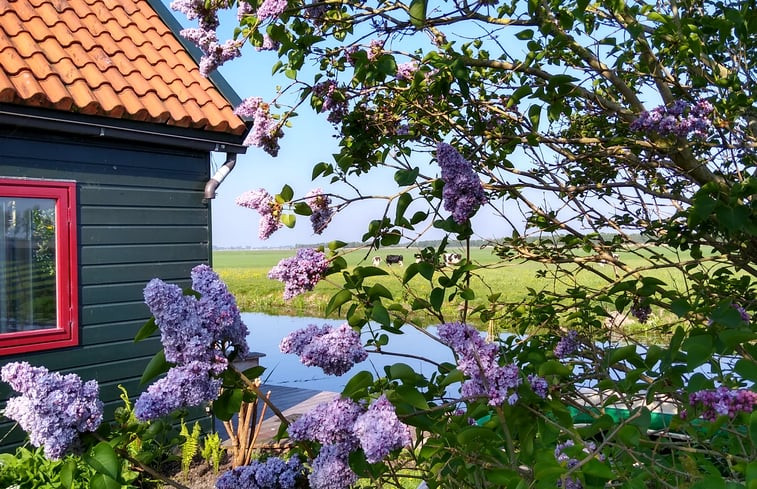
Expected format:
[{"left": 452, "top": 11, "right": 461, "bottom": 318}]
[{"left": 242, "top": 313, "right": 452, "bottom": 392}]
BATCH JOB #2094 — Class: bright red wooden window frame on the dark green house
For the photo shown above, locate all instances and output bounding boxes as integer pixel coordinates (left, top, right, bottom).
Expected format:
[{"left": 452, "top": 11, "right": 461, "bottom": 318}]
[{"left": 0, "top": 178, "right": 79, "bottom": 355}]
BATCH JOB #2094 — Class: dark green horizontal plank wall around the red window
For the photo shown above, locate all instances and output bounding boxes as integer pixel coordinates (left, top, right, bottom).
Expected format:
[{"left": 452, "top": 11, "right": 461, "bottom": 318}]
[{"left": 0, "top": 126, "right": 211, "bottom": 451}]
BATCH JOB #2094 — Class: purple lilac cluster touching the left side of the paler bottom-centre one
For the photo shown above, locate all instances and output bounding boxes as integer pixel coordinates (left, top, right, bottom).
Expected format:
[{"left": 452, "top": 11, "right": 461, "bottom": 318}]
[{"left": 287, "top": 398, "right": 364, "bottom": 449}]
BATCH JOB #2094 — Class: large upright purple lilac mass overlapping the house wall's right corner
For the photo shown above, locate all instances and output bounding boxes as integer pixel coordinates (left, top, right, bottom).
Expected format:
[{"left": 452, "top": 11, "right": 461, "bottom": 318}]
[{"left": 134, "top": 265, "right": 248, "bottom": 420}]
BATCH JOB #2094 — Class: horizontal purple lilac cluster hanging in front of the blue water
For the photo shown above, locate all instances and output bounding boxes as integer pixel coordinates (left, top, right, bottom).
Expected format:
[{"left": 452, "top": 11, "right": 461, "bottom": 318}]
[{"left": 279, "top": 323, "right": 368, "bottom": 375}]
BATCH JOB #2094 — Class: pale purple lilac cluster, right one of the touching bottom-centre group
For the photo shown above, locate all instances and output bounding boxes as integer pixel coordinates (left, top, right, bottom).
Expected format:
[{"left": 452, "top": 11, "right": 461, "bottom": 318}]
[{"left": 353, "top": 395, "right": 412, "bottom": 463}]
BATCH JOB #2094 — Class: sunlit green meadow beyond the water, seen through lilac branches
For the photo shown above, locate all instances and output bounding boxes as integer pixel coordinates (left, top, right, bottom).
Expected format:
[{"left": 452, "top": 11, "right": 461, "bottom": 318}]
[{"left": 213, "top": 247, "right": 682, "bottom": 336}]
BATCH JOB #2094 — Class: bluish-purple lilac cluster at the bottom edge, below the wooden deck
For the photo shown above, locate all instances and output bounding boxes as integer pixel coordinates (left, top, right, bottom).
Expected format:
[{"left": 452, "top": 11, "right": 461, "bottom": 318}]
[{"left": 216, "top": 455, "right": 305, "bottom": 489}]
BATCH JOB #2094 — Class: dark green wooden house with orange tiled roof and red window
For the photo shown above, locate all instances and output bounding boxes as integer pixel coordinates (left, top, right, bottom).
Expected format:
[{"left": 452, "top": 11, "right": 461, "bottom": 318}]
[{"left": 0, "top": 0, "right": 247, "bottom": 450}]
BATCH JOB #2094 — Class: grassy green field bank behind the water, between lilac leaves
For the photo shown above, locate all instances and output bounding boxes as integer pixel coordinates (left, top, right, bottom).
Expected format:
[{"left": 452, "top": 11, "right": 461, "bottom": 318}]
[{"left": 213, "top": 249, "right": 679, "bottom": 332}]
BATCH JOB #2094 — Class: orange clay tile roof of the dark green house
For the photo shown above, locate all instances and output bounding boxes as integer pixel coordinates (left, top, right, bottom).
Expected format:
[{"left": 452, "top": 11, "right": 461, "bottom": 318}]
[{"left": 0, "top": 0, "right": 245, "bottom": 135}]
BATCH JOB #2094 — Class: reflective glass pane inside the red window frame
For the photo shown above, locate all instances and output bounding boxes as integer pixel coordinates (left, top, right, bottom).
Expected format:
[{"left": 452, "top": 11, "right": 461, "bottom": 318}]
[{"left": 0, "top": 197, "right": 57, "bottom": 333}]
